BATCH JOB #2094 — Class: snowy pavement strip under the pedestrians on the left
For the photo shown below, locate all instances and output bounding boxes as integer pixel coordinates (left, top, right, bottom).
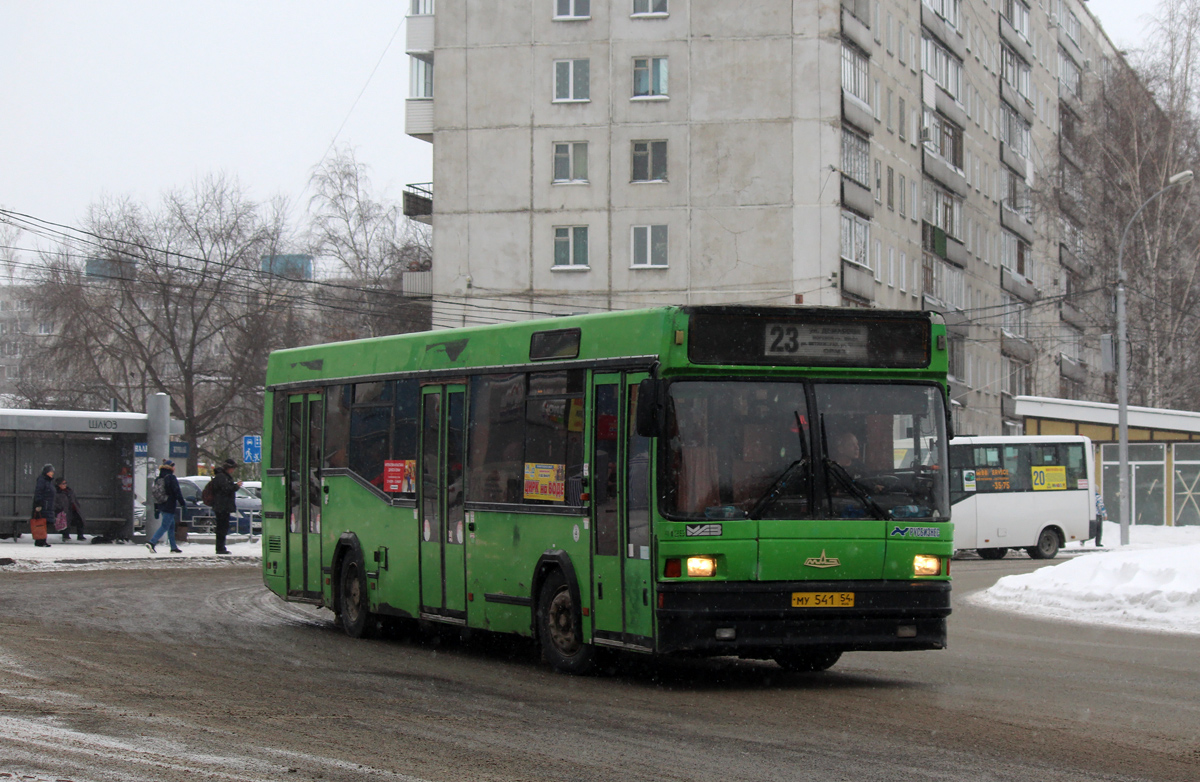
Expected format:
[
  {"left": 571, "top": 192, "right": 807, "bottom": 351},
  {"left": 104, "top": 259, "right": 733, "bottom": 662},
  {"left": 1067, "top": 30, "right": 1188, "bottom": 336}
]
[{"left": 0, "top": 535, "right": 263, "bottom": 573}]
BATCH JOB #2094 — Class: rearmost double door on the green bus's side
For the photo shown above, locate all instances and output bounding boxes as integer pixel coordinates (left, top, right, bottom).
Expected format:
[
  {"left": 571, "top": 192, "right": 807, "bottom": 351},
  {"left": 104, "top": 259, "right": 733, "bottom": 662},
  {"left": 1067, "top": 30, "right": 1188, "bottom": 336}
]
[{"left": 284, "top": 393, "right": 324, "bottom": 598}]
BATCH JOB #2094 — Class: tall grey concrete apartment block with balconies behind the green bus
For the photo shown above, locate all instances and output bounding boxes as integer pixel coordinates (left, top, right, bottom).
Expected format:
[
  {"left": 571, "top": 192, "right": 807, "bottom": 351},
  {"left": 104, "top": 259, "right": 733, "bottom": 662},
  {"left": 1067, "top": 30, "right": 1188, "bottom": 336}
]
[{"left": 406, "top": 0, "right": 1117, "bottom": 433}]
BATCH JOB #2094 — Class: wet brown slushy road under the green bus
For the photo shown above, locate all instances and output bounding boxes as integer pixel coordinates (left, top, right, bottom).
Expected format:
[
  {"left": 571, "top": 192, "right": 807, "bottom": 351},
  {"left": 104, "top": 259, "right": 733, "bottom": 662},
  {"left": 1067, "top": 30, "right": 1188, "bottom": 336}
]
[{"left": 0, "top": 559, "right": 1200, "bottom": 782}]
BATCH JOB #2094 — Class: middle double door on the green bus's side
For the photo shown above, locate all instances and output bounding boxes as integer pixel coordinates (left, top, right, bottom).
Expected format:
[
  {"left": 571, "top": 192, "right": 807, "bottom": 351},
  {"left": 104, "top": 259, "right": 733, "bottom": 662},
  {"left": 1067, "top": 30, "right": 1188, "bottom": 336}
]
[{"left": 416, "top": 385, "right": 467, "bottom": 624}]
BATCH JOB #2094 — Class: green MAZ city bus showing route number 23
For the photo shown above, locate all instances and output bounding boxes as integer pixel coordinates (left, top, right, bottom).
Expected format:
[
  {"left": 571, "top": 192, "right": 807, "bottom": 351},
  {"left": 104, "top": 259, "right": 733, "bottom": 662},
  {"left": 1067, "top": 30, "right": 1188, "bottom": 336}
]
[{"left": 263, "top": 306, "right": 954, "bottom": 673}]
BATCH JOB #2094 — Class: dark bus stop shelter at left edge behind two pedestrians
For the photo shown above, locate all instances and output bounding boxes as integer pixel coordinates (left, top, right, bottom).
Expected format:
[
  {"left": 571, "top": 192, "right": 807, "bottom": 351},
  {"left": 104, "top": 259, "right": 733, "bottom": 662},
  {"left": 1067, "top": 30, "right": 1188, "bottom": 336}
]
[{"left": 0, "top": 409, "right": 182, "bottom": 537}]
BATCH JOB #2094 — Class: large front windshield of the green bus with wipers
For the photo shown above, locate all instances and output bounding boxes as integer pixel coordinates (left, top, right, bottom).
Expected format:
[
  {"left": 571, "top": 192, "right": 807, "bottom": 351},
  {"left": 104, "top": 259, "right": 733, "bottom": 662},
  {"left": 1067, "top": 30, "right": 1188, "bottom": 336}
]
[{"left": 661, "top": 380, "right": 949, "bottom": 519}]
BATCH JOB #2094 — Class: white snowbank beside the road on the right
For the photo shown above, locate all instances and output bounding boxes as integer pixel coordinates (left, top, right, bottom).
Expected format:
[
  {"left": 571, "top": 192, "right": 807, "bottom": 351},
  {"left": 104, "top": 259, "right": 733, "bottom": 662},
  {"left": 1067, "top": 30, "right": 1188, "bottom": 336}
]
[{"left": 967, "top": 522, "right": 1200, "bottom": 634}]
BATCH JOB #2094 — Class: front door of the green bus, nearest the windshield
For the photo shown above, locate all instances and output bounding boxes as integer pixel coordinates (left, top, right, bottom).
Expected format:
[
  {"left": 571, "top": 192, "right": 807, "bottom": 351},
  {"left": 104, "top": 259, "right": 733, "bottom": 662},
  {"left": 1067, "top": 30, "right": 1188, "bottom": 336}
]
[{"left": 592, "top": 374, "right": 654, "bottom": 649}]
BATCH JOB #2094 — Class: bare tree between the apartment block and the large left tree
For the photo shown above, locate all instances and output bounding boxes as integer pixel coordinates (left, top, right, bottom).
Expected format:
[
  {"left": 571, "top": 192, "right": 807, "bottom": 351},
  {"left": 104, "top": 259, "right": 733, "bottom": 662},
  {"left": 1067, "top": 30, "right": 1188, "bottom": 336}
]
[{"left": 308, "top": 149, "right": 432, "bottom": 339}]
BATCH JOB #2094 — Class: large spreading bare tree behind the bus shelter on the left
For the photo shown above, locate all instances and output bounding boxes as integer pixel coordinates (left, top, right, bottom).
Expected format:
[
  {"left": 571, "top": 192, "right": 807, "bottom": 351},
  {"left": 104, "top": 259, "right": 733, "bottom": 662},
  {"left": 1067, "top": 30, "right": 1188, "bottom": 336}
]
[{"left": 19, "top": 176, "right": 304, "bottom": 470}]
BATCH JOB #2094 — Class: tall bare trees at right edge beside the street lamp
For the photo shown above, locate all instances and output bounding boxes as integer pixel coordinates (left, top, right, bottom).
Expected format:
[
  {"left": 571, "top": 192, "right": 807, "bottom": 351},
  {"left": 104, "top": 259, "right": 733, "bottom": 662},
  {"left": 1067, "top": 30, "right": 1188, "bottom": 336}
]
[{"left": 1061, "top": 7, "right": 1200, "bottom": 409}]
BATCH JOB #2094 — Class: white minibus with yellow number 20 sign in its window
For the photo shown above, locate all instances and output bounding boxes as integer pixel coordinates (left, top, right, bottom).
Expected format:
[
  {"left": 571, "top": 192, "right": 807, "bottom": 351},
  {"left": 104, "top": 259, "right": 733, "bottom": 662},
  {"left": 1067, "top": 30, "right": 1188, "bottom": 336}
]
[{"left": 950, "top": 435, "right": 1096, "bottom": 559}]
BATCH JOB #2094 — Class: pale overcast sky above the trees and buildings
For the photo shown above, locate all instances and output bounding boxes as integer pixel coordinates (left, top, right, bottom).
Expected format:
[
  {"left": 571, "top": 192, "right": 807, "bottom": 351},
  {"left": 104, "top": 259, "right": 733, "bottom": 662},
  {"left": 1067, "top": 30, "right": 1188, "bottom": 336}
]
[{"left": 0, "top": 0, "right": 1153, "bottom": 241}]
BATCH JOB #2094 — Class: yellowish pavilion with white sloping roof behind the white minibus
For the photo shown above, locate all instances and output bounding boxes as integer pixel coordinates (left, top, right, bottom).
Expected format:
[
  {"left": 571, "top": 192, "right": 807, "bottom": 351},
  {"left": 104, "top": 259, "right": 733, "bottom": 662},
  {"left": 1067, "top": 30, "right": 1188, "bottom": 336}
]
[{"left": 1012, "top": 396, "right": 1200, "bottom": 527}]
